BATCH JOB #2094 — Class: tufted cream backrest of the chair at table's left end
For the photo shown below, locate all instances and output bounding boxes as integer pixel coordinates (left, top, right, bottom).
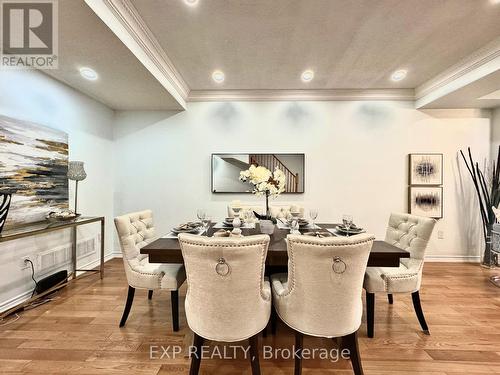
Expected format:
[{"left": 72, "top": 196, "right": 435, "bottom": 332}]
[{"left": 115, "top": 210, "right": 155, "bottom": 287}]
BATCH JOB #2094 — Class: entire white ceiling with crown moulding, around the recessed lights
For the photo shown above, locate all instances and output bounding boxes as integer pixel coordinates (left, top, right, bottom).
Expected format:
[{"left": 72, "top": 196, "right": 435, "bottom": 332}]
[{"left": 42, "top": 0, "right": 500, "bottom": 110}]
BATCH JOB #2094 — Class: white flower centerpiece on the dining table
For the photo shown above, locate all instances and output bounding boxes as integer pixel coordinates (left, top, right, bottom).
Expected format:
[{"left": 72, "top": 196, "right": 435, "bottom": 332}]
[{"left": 240, "top": 164, "right": 286, "bottom": 220}]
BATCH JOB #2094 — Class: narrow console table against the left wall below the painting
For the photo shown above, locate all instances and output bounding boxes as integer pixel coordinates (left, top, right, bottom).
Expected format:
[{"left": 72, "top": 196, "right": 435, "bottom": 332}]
[{"left": 0, "top": 216, "right": 104, "bottom": 279}]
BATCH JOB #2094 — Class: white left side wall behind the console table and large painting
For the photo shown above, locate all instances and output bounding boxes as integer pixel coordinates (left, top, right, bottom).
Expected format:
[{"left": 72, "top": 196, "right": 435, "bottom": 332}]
[{"left": 0, "top": 70, "right": 113, "bottom": 310}]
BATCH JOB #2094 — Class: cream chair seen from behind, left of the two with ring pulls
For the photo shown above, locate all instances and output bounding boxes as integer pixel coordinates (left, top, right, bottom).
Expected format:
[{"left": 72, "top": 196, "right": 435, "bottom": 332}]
[{"left": 179, "top": 234, "right": 271, "bottom": 375}]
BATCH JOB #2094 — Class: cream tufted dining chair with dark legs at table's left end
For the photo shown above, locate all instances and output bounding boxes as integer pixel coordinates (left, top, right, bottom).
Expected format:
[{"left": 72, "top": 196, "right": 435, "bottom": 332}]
[{"left": 115, "top": 210, "right": 186, "bottom": 331}]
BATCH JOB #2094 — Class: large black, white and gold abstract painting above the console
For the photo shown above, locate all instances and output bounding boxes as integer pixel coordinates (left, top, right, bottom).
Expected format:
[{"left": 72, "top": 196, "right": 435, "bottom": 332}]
[{"left": 0, "top": 116, "right": 68, "bottom": 228}]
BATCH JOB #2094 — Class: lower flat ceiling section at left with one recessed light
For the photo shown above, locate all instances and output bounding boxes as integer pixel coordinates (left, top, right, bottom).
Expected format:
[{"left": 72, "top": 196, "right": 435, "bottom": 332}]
[{"left": 45, "top": 0, "right": 182, "bottom": 110}]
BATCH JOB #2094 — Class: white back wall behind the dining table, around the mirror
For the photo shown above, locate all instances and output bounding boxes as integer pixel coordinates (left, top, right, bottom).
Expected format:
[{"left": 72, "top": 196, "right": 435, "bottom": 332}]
[{"left": 114, "top": 102, "right": 490, "bottom": 259}]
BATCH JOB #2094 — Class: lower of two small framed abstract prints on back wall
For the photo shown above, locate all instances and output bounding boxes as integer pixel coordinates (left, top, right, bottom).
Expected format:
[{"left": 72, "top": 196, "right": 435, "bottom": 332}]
[{"left": 409, "top": 186, "right": 443, "bottom": 219}]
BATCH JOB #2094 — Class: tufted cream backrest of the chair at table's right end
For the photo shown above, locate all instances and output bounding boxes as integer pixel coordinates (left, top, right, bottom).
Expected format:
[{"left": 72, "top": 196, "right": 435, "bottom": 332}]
[{"left": 385, "top": 213, "right": 436, "bottom": 269}]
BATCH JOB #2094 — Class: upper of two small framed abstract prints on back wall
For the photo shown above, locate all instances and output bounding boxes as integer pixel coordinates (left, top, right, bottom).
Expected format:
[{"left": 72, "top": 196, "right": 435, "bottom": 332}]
[{"left": 410, "top": 154, "right": 443, "bottom": 185}]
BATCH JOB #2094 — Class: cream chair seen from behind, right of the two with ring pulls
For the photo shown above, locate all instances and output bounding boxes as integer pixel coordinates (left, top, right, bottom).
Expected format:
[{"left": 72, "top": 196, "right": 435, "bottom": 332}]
[{"left": 271, "top": 234, "right": 374, "bottom": 375}]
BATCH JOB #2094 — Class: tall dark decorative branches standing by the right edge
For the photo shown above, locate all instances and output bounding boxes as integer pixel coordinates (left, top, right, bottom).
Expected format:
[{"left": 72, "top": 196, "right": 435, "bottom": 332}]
[{"left": 460, "top": 146, "right": 500, "bottom": 268}]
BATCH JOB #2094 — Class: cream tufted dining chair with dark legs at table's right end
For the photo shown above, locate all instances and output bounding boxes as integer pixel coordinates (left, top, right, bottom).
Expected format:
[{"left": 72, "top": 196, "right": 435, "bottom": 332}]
[{"left": 364, "top": 213, "right": 436, "bottom": 337}]
